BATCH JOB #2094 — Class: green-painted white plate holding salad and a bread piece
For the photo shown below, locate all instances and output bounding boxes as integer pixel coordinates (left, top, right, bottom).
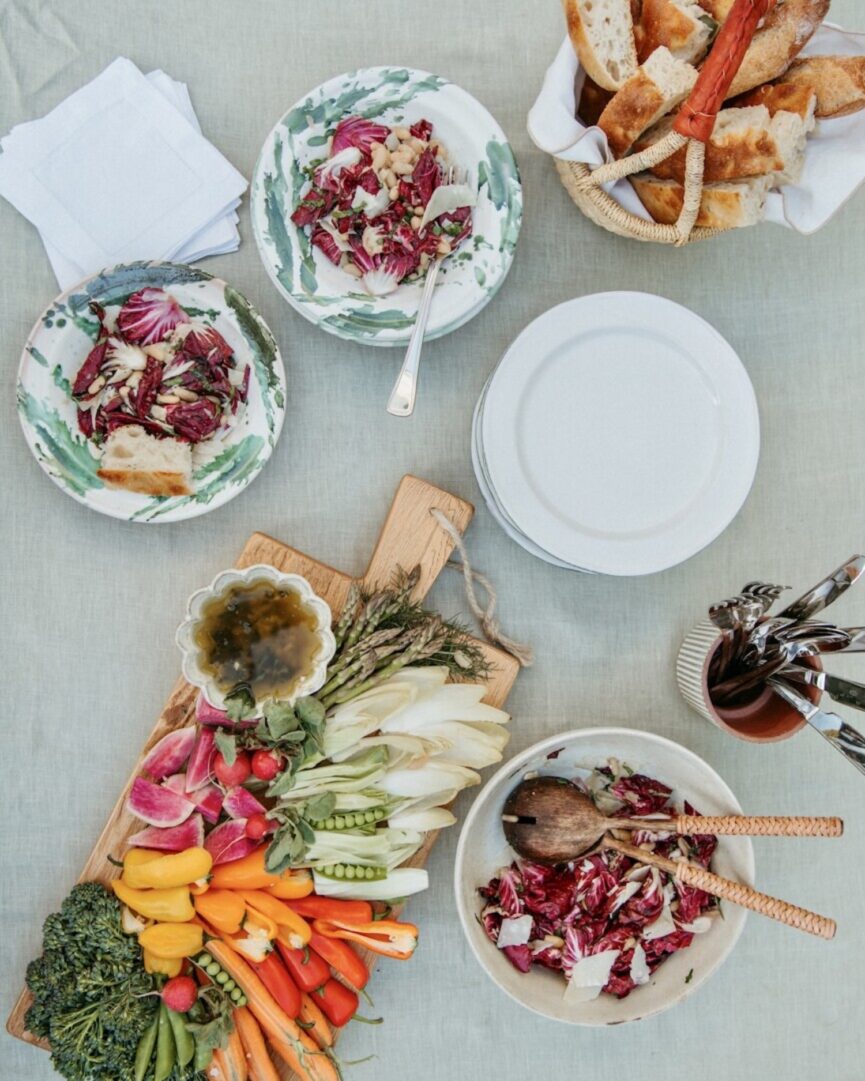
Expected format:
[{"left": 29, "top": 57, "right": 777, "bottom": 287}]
[{"left": 17, "top": 263, "right": 285, "bottom": 522}]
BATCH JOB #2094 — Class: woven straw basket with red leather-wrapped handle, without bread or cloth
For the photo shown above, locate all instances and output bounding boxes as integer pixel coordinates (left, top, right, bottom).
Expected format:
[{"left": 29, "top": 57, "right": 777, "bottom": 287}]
[{"left": 555, "top": 0, "right": 773, "bottom": 248}]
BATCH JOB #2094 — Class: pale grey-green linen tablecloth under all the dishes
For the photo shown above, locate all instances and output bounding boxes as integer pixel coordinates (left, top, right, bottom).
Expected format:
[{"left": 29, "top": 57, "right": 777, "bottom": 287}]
[{"left": 0, "top": 0, "right": 865, "bottom": 1081}]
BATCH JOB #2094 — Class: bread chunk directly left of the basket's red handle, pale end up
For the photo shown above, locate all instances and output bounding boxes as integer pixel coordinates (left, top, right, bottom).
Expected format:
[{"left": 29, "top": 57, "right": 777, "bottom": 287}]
[{"left": 598, "top": 45, "right": 696, "bottom": 158}]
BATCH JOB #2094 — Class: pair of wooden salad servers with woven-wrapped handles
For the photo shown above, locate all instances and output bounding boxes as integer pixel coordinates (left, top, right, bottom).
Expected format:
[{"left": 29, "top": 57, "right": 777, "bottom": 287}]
[{"left": 502, "top": 777, "right": 843, "bottom": 938}]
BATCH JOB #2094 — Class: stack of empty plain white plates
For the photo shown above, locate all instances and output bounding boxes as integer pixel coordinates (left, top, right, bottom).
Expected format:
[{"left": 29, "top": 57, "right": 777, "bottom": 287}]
[{"left": 471, "top": 293, "right": 760, "bottom": 575}]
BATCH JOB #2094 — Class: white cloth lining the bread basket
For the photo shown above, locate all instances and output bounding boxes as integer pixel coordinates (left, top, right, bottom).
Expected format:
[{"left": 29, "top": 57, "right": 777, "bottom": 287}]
[{"left": 528, "top": 23, "right": 865, "bottom": 233}]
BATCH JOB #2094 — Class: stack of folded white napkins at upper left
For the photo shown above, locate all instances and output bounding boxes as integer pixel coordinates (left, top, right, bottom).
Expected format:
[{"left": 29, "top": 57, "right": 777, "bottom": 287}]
[{"left": 0, "top": 57, "right": 247, "bottom": 289}]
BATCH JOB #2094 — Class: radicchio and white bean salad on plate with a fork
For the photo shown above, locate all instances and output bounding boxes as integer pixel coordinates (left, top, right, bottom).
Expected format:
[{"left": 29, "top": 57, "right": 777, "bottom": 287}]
[{"left": 291, "top": 117, "right": 475, "bottom": 296}]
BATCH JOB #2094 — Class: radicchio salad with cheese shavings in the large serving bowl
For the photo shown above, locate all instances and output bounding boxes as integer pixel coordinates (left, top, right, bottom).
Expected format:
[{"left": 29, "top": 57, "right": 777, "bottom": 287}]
[{"left": 478, "top": 759, "right": 719, "bottom": 1002}]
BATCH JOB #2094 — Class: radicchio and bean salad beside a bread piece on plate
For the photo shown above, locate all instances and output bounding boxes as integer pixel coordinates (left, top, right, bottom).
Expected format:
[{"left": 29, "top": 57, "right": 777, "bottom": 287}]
[{"left": 71, "top": 289, "right": 250, "bottom": 444}]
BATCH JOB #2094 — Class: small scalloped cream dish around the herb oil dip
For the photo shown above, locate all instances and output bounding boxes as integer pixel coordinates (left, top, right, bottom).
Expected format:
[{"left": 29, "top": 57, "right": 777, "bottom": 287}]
[{"left": 175, "top": 563, "right": 336, "bottom": 709}]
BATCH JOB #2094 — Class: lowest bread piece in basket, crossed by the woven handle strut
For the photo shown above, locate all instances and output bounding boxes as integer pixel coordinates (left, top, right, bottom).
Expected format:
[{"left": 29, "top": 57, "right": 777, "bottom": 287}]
[{"left": 629, "top": 173, "right": 772, "bottom": 229}]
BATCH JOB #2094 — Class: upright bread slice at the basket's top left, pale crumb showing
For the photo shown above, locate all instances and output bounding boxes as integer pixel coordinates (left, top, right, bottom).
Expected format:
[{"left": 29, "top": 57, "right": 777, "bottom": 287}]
[{"left": 563, "top": 0, "right": 637, "bottom": 90}]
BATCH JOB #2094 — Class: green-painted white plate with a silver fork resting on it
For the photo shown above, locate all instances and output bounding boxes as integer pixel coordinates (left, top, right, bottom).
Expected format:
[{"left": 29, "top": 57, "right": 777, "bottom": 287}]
[{"left": 251, "top": 67, "right": 522, "bottom": 345}]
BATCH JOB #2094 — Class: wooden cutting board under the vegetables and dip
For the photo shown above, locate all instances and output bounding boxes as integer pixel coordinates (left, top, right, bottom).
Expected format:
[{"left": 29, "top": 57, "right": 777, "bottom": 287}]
[{"left": 6, "top": 476, "right": 519, "bottom": 1081}]
